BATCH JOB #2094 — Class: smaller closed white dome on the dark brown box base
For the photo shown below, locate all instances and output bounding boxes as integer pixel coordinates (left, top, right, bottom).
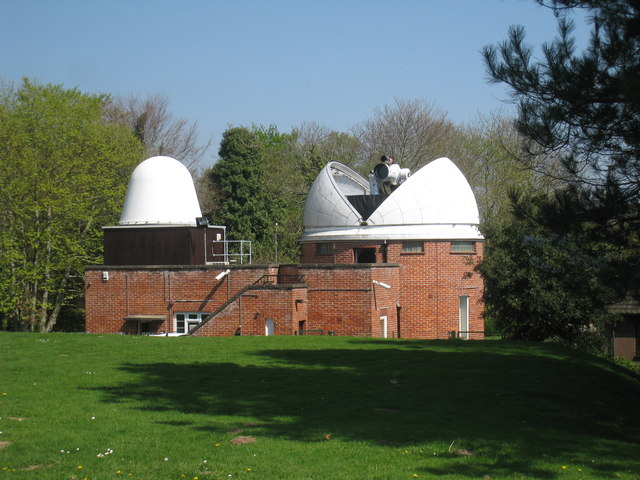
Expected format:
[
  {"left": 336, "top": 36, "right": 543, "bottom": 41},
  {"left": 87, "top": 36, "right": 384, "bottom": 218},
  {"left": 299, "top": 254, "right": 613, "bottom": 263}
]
[{"left": 120, "top": 157, "right": 202, "bottom": 226}]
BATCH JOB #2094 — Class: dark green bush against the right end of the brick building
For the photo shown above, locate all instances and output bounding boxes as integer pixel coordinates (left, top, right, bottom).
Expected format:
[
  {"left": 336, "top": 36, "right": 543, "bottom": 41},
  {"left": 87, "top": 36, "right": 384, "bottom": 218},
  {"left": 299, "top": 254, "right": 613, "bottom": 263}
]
[{"left": 478, "top": 195, "right": 620, "bottom": 347}]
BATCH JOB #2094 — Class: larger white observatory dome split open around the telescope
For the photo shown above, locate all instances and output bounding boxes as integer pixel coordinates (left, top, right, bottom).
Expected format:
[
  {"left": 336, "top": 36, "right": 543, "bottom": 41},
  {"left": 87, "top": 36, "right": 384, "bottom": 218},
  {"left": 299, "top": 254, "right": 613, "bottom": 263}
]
[{"left": 301, "top": 157, "right": 482, "bottom": 242}]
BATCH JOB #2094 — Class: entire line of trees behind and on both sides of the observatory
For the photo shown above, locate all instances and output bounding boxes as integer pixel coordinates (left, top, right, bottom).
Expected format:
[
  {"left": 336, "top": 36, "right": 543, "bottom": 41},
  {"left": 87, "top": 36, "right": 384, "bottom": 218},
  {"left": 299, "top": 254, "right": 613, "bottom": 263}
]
[{"left": 0, "top": 0, "right": 640, "bottom": 356}]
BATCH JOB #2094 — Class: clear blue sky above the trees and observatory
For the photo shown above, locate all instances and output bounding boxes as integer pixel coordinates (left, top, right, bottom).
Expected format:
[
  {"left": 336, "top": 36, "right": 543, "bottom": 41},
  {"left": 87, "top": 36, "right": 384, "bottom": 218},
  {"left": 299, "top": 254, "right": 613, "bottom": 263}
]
[{"left": 0, "top": 0, "right": 592, "bottom": 166}]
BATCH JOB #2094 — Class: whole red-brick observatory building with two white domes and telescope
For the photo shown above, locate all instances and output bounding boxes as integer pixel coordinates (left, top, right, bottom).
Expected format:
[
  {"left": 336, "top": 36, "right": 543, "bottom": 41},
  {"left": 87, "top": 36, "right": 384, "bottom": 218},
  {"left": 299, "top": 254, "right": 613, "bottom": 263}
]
[{"left": 85, "top": 157, "right": 484, "bottom": 338}]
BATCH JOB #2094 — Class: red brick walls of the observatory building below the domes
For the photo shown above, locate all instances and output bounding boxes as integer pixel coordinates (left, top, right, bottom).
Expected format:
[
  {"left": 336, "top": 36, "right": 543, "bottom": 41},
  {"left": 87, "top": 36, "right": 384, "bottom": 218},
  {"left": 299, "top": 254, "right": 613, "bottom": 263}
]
[{"left": 85, "top": 241, "right": 484, "bottom": 338}]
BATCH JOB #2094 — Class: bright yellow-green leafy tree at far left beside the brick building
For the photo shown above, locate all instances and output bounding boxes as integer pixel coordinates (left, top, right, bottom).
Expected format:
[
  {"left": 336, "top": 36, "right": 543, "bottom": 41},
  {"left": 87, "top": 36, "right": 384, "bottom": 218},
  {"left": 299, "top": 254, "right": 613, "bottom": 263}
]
[{"left": 0, "top": 79, "right": 142, "bottom": 331}]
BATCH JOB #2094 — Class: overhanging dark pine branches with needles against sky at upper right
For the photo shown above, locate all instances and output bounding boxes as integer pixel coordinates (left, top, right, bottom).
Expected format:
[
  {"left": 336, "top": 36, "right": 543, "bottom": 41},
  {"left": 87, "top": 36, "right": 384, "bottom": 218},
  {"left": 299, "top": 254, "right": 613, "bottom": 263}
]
[{"left": 483, "top": 0, "right": 640, "bottom": 191}]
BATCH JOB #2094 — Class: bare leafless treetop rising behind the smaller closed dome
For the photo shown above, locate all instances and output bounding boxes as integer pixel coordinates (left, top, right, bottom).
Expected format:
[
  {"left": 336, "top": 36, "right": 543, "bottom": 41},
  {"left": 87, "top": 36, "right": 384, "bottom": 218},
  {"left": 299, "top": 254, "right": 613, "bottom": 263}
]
[{"left": 106, "top": 95, "right": 212, "bottom": 171}]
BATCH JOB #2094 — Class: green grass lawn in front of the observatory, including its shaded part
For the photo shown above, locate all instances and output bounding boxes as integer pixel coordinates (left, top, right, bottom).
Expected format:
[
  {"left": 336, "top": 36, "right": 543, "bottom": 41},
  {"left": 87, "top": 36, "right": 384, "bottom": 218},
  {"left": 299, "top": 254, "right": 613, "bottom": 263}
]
[{"left": 0, "top": 333, "right": 640, "bottom": 480}]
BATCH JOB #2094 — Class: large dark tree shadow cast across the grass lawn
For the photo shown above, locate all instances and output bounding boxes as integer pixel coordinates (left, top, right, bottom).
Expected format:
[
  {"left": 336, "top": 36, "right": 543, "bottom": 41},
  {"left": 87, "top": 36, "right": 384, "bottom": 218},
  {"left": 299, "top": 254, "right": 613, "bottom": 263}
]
[{"left": 90, "top": 341, "right": 640, "bottom": 478}]
